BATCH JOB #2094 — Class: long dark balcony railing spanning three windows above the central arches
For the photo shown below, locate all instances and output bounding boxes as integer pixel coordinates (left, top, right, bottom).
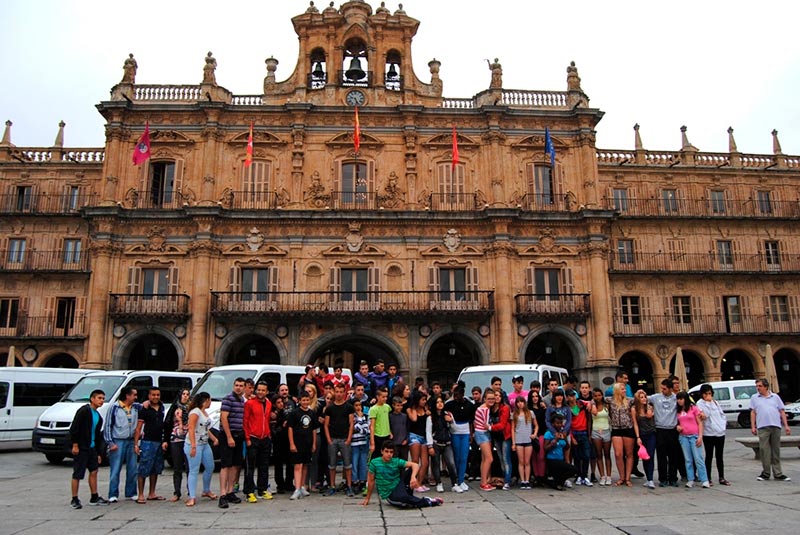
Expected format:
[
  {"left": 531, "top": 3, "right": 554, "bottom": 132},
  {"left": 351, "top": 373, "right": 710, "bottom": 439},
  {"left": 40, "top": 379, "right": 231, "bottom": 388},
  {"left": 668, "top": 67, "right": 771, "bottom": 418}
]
[{"left": 211, "top": 291, "right": 494, "bottom": 320}]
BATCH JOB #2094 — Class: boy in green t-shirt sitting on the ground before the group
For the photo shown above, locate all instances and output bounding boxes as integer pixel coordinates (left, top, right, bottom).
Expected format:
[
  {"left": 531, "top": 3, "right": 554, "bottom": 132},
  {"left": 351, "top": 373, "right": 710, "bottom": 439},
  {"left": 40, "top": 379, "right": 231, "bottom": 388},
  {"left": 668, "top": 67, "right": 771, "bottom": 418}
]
[{"left": 361, "top": 440, "right": 443, "bottom": 507}]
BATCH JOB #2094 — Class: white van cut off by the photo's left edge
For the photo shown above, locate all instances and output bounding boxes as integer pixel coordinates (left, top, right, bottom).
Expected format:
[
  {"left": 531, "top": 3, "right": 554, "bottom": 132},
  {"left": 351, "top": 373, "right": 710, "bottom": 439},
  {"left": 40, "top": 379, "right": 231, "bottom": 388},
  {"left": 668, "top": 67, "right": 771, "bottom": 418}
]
[{"left": 0, "top": 367, "right": 92, "bottom": 449}]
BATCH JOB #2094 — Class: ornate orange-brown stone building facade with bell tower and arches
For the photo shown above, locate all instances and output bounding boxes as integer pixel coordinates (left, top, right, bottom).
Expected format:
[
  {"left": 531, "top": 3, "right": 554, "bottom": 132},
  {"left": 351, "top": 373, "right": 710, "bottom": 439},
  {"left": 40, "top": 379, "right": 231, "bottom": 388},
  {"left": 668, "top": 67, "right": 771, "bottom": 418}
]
[{"left": 0, "top": 1, "right": 800, "bottom": 398}]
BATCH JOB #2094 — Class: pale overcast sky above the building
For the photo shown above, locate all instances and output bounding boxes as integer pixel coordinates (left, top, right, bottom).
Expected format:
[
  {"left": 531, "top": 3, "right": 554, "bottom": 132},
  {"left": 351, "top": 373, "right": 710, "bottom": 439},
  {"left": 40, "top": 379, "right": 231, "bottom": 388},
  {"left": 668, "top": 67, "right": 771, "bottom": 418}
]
[{"left": 0, "top": 0, "right": 800, "bottom": 155}]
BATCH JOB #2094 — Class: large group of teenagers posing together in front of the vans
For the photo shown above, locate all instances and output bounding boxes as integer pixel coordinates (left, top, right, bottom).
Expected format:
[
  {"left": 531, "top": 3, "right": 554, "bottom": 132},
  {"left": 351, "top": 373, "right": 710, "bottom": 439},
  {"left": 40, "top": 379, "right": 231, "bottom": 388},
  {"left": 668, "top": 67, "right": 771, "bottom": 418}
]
[{"left": 71, "top": 361, "right": 788, "bottom": 508}]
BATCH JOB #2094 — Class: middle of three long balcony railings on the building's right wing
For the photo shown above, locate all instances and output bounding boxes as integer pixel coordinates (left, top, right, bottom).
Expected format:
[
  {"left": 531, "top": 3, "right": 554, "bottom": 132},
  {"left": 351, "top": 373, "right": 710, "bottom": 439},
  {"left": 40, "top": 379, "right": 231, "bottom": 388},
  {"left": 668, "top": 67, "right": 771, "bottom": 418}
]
[{"left": 609, "top": 252, "right": 800, "bottom": 274}]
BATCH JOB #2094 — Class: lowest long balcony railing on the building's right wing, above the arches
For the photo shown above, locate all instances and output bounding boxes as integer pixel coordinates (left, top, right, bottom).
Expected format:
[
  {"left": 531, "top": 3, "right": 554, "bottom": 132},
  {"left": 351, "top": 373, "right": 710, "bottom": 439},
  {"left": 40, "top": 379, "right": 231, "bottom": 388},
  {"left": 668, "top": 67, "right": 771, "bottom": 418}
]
[{"left": 614, "top": 314, "right": 800, "bottom": 336}]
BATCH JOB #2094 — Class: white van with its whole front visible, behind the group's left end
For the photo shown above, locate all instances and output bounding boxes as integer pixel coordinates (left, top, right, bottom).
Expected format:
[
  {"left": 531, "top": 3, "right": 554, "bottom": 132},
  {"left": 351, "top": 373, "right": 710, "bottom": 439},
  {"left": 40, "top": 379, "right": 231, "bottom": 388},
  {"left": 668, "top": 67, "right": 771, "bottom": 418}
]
[{"left": 32, "top": 370, "right": 202, "bottom": 463}]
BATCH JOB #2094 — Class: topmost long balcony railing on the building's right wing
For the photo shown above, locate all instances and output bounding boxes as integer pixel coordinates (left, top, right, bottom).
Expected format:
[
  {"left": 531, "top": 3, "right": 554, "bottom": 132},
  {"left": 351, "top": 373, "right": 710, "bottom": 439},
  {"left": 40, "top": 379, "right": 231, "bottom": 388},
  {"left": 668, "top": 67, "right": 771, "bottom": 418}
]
[{"left": 603, "top": 197, "right": 800, "bottom": 219}]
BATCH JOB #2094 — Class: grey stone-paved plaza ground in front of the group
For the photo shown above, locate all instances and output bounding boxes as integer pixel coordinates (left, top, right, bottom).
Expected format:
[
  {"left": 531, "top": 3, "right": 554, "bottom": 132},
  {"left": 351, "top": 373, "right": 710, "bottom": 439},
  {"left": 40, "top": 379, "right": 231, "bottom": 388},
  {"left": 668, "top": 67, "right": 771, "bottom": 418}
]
[{"left": 0, "top": 428, "right": 800, "bottom": 535}]
